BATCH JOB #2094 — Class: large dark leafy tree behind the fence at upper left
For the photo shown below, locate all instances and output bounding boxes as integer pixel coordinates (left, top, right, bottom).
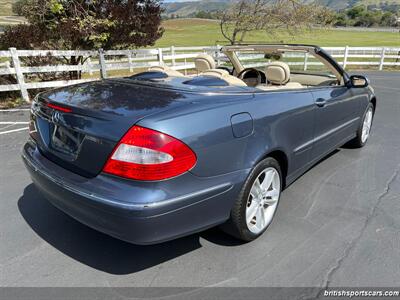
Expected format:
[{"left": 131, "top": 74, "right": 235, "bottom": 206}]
[{"left": 0, "top": 0, "right": 163, "bottom": 78}]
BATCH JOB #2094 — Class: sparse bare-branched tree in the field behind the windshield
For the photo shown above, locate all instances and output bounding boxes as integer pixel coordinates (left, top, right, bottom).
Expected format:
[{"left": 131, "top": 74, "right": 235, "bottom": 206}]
[{"left": 219, "top": 0, "right": 334, "bottom": 44}]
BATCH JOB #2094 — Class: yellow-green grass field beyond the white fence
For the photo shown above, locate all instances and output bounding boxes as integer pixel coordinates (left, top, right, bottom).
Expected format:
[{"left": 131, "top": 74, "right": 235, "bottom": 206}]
[{"left": 156, "top": 19, "right": 400, "bottom": 47}]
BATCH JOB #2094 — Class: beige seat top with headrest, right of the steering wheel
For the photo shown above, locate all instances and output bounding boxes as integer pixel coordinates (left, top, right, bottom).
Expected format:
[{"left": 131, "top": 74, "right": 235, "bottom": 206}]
[{"left": 257, "top": 61, "right": 303, "bottom": 90}]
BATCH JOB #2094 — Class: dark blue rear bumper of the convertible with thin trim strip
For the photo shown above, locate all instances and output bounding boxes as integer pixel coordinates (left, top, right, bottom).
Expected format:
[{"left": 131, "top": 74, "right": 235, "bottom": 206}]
[{"left": 22, "top": 141, "right": 247, "bottom": 244}]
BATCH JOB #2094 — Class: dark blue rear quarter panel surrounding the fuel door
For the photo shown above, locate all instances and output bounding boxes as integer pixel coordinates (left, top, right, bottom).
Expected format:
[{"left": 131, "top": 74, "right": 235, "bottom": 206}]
[{"left": 138, "top": 91, "right": 314, "bottom": 183}]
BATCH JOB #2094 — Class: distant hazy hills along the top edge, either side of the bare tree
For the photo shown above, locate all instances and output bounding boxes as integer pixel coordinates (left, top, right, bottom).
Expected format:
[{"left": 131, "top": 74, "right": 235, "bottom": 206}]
[{"left": 163, "top": 0, "right": 400, "bottom": 17}]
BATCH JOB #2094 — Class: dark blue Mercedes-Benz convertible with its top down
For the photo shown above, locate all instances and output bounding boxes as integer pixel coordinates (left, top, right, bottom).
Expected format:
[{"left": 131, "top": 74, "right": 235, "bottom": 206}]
[{"left": 22, "top": 45, "right": 376, "bottom": 244}]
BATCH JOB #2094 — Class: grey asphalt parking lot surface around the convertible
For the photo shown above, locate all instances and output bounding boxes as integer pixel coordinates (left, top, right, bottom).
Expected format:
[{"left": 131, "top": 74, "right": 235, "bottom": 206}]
[{"left": 0, "top": 72, "right": 400, "bottom": 288}]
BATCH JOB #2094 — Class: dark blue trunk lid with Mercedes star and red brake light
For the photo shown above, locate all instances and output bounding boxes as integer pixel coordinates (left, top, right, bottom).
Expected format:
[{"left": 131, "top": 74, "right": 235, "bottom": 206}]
[{"left": 30, "top": 80, "right": 187, "bottom": 177}]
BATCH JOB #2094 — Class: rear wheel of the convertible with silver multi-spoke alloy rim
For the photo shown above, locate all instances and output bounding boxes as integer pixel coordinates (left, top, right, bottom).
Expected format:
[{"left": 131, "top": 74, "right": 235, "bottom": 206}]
[{"left": 222, "top": 157, "right": 282, "bottom": 242}]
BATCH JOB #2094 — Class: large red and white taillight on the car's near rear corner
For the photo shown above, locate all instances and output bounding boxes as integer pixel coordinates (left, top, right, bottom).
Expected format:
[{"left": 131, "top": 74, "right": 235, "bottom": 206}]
[{"left": 103, "top": 126, "right": 196, "bottom": 180}]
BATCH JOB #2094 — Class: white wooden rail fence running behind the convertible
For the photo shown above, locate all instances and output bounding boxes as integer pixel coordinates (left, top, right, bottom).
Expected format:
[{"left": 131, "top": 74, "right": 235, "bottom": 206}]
[{"left": 0, "top": 45, "right": 400, "bottom": 102}]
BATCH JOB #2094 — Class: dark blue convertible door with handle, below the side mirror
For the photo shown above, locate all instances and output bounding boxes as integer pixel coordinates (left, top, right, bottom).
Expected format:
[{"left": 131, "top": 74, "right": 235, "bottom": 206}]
[{"left": 311, "top": 85, "right": 359, "bottom": 159}]
